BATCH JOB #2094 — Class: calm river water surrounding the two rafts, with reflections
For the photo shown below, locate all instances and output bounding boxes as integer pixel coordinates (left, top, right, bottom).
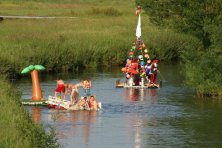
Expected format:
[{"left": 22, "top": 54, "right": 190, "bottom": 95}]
[{"left": 16, "top": 64, "right": 222, "bottom": 148}]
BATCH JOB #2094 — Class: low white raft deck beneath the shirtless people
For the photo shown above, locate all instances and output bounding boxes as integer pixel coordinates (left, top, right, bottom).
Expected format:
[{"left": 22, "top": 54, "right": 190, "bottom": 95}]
[{"left": 46, "top": 96, "right": 102, "bottom": 110}]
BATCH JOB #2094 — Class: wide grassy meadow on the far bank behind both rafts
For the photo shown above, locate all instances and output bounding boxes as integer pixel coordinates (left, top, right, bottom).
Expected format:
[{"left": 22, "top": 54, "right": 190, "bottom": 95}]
[{"left": 0, "top": 0, "right": 198, "bottom": 77}]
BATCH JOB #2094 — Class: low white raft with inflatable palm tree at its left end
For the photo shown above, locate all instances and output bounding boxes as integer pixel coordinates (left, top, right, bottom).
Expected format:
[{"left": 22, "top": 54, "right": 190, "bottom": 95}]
[{"left": 21, "top": 65, "right": 102, "bottom": 110}]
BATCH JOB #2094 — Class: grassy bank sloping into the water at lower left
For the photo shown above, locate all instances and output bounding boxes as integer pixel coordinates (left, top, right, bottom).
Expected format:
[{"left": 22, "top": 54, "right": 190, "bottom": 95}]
[{"left": 0, "top": 76, "right": 59, "bottom": 148}]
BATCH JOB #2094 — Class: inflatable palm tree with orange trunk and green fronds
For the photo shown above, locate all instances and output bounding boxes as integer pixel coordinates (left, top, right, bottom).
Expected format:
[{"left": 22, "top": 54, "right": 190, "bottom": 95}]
[{"left": 21, "top": 65, "right": 45, "bottom": 101}]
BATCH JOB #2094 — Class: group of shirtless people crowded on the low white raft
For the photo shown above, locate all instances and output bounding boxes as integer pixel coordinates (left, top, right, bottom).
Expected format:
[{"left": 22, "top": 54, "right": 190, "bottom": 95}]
[{"left": 54, "top": 79, "right": 98, "bottom": 110}]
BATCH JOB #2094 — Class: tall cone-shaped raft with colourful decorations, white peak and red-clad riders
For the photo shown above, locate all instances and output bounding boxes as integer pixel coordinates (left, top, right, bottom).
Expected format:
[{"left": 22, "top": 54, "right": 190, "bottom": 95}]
[{"left": 116, "top": 6, "right": 161, "bottom": 89}]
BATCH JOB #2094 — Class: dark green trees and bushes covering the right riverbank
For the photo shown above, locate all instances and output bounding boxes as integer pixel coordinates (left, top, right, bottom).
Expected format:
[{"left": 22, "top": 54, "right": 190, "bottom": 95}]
[{"left": 142, "top": 0, "right": 222, "bottom": 97}]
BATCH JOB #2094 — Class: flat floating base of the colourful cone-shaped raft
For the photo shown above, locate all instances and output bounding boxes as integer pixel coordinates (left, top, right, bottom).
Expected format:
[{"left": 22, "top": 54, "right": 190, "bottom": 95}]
[{"left": 116, "top": 80, "right": 161, "bottom": 89}]
